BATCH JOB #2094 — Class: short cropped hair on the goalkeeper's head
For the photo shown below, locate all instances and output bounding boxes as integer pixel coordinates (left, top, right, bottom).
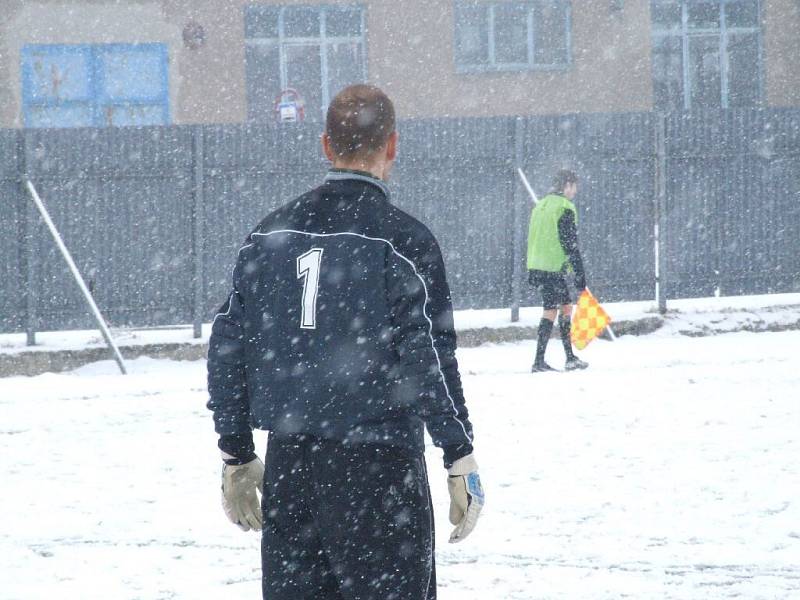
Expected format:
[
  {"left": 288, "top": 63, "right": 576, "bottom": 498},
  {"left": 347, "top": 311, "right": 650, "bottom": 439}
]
[{"left": 325, "top": 84, "right": 395, "bottom": 160}]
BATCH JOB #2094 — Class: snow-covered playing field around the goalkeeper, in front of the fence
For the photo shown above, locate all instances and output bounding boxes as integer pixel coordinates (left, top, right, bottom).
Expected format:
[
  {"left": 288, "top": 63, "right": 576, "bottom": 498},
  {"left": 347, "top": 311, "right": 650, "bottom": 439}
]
[{"left": 0, "top": 331, "right": 800, "bottom": 600}]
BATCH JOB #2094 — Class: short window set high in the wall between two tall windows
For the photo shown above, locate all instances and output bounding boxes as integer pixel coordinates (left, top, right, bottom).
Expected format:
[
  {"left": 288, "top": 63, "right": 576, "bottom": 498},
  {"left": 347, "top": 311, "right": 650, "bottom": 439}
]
[{"left": 455, "top": 0, "right": 571, "bottom": 73}]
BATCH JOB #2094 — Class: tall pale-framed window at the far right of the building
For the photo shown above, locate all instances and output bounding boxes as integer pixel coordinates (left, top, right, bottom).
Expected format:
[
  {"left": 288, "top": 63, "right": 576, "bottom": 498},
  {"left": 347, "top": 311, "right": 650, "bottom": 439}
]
[{"left": 650, "top": 0, "right": 763, "bottom": 111}]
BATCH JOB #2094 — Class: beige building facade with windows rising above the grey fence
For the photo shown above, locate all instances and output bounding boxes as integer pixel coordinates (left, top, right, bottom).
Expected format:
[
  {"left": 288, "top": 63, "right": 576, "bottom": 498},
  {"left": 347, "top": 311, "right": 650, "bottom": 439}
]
[{"left": 0, "top": 0, "right": 800, "bottom": 128}]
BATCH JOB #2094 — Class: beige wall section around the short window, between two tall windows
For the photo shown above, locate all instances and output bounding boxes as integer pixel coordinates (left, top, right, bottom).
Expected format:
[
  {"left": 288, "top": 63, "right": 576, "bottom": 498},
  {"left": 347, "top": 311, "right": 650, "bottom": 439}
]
[{"left": 369, "top": 0, "right": 652, "bottom": 117}]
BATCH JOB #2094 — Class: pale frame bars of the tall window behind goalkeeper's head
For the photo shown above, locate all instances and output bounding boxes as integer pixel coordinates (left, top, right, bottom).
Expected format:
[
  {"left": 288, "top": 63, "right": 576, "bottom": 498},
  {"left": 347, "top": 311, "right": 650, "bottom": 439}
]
[{"left": 244, "top": 2, "right": 368, "bottom": 122}]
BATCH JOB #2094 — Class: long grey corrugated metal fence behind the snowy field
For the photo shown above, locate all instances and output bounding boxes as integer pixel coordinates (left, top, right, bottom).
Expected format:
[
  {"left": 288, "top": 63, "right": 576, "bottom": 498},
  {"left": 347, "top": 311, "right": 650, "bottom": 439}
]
[{"left": 0, "top": 109, "right": 800, "bottom": 339}]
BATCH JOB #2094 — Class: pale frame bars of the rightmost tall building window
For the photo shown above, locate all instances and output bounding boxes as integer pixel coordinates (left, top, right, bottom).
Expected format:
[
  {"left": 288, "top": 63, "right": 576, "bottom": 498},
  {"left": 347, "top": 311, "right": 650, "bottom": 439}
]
[{"left": 650, "top": 0, "right": 765, "bottom": 111}]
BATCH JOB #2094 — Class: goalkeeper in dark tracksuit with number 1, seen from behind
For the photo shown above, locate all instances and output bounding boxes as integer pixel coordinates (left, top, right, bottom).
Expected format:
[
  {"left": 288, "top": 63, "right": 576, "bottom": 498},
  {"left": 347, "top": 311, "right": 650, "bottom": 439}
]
[{"left": 208, "top": 85, "right": 483, "bottom": 600}]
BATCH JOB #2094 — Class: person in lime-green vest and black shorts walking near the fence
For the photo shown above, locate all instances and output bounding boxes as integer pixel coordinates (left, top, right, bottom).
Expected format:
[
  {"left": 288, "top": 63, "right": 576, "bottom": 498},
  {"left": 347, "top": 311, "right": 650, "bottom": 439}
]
[{"left": 528, "top": 169, "right": 589, "bottom": 373}]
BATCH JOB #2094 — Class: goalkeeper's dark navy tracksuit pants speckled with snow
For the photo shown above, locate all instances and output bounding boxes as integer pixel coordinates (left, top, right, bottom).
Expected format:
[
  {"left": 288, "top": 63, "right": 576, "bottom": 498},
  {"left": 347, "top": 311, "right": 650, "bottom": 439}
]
[{"left": 262, "top": 434, "right": 436, "bottom": 600}]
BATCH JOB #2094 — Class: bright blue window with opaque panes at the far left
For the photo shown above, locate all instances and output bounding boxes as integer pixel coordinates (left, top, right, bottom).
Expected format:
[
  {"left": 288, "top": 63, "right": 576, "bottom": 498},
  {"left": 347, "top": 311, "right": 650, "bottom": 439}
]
[{"left": 22, "top": 44, "right": 169, "bottom": 127}]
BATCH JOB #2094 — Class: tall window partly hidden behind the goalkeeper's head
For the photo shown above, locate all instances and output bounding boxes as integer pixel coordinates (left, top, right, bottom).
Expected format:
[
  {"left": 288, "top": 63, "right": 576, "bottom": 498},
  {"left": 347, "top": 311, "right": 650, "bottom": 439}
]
[{"left": 245, "top": 5, "right": 367, "bottom": 121}]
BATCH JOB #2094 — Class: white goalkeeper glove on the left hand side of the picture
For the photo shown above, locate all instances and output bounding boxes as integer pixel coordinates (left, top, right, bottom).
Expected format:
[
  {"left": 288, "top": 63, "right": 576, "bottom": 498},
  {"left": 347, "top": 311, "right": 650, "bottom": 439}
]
[{"left": 222, "top": 457, "right": 264, "bottom": 531}]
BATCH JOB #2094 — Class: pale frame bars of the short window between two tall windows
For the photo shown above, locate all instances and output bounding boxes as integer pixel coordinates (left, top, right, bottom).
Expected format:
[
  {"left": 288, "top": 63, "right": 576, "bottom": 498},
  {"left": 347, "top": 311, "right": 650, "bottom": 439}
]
[{"left": 453, "top": 0, "right": 573, "bottom": 75}]
